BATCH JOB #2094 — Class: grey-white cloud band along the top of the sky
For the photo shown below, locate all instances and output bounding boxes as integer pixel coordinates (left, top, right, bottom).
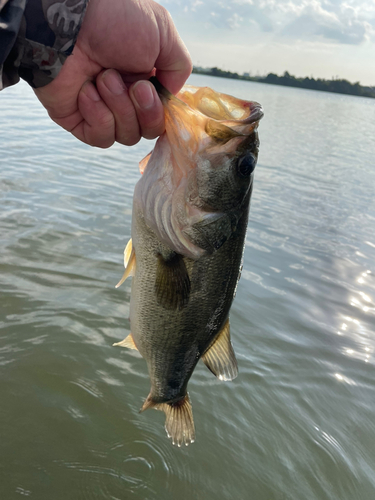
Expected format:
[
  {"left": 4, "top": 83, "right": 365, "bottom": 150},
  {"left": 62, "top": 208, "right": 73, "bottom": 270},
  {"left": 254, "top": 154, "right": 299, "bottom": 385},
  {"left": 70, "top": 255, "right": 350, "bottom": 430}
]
[{"left": 161, "top": 0, "right": 375, "bottom": 45}]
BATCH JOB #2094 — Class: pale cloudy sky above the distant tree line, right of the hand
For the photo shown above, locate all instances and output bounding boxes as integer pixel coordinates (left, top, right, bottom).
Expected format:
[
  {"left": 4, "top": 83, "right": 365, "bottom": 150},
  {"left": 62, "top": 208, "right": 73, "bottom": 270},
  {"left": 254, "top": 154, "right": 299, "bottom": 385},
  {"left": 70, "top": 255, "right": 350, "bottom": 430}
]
[{"left": 159, "top": 0, "right": 375, "bottom": 86}]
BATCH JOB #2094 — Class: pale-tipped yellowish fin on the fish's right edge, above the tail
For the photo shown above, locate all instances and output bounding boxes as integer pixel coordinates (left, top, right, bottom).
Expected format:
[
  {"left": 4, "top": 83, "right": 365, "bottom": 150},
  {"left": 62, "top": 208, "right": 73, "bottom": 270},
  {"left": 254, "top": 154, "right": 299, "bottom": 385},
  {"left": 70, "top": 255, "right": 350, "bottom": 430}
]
[{"left": 202, "top": 318, "right": 238, "bottom": 380}]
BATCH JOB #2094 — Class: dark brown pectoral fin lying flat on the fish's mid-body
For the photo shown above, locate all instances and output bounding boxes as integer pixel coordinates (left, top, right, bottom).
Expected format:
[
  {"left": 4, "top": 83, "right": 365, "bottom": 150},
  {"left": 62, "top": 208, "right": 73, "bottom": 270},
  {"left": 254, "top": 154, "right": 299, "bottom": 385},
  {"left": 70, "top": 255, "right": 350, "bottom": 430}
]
[{"left": 155, "top": 253, "right": 190, "bottom": 310}]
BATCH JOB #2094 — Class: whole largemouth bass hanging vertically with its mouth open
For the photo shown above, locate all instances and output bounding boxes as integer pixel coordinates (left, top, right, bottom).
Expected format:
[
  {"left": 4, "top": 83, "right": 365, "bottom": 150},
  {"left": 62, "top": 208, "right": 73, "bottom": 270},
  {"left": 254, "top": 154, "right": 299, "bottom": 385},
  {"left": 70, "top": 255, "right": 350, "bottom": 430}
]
[{"left": 114, "top": 77, "right": 263, "bottom": 446}]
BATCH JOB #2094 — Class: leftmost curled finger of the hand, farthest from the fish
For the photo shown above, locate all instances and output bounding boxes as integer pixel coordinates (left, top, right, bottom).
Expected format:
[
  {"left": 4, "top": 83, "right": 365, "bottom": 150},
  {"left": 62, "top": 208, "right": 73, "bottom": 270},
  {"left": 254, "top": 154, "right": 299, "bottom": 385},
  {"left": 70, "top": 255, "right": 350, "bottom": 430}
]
[{"left": 71, "top": 82, "right": 115, "bottom": 148}]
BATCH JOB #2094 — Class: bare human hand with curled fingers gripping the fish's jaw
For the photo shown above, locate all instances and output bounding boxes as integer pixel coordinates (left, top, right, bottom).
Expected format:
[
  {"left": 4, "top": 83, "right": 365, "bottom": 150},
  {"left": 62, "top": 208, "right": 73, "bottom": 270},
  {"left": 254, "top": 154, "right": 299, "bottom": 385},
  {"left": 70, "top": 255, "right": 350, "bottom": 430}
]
[{"left": 35, "top": 0, "right": 191, "bottom": 148}]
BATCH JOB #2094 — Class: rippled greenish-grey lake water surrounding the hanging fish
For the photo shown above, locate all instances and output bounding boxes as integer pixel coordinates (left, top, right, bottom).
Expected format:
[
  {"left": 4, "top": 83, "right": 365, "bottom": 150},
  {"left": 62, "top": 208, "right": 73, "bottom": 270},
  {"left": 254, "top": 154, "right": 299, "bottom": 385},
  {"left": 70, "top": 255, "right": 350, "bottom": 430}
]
[{"left": 0, "top": 75, "right": 375, "bottom": 500}]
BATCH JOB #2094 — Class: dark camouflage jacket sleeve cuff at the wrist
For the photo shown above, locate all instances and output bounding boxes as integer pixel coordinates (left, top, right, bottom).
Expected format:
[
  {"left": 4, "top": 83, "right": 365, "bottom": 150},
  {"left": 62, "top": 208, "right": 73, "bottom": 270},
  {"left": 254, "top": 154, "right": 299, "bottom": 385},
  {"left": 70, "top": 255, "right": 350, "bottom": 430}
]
[{"left": 0, "top": 0, "right": 88, "bottom": 90}]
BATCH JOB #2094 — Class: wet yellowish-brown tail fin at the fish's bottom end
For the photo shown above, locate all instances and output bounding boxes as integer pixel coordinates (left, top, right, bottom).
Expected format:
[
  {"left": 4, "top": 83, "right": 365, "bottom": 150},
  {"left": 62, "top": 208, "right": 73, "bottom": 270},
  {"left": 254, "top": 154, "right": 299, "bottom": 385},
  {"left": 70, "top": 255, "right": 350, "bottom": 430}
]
[{"left": 141, "top": 394, "right": 195, "bottom": 447}]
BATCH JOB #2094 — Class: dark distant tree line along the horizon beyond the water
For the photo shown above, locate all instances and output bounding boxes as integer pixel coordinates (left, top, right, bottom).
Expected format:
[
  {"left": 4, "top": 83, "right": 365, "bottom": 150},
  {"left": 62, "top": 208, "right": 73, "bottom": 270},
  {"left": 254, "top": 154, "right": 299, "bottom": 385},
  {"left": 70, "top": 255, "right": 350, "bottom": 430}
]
[{"left": 193, "top": 67, "right": 375, "bottom": 98}]
